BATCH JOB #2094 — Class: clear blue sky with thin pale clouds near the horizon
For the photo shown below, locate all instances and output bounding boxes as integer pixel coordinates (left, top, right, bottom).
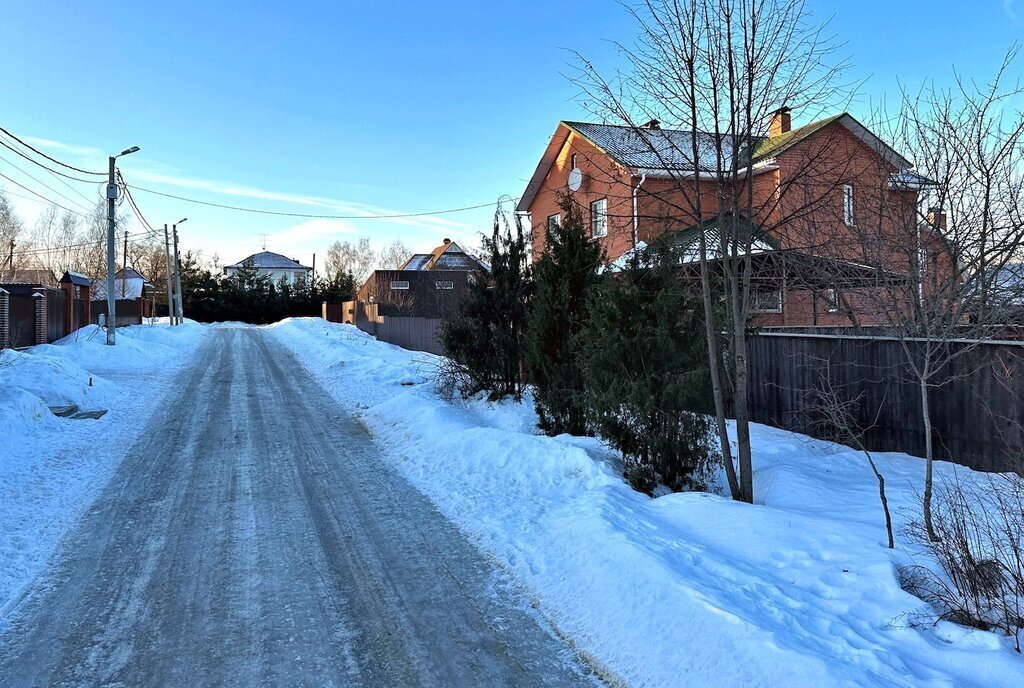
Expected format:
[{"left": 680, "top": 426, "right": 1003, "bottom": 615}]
[{"left": 0, "top": 0, "right": 1024, "bottom": 264}]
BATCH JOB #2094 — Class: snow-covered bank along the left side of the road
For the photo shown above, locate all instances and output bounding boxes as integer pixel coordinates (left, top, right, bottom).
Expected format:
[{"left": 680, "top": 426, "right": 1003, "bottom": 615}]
[{"left": 0, "top": 319, "right": 207, "bottom": 617}]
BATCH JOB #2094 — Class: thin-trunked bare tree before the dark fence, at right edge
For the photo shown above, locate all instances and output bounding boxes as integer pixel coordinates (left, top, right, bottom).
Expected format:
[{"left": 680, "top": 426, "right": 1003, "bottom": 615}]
[{"left": 850, "top": 49, "right": 1024, "bottom": 539}]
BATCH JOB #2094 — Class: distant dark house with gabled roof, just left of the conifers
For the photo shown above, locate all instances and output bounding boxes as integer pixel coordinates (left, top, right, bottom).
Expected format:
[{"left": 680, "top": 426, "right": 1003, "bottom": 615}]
[{"left": 356, "top": 239, "right": 487, "bottom": 318}]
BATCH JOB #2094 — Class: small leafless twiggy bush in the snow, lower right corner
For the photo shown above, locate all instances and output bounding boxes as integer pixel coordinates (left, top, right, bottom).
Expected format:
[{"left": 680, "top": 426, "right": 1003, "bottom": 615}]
[{"left": 900, "top": 474, "right": 1024, "bottom": 652}]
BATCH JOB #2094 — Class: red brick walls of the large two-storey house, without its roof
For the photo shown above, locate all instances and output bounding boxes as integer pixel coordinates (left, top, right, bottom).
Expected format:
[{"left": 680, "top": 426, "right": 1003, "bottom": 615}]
[{"left": 529, "top": 123, "right": 929, "bottom": 327}]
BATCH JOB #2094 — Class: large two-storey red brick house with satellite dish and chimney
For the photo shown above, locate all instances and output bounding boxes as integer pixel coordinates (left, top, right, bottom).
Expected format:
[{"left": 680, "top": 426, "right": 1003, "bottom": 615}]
[{"left": 516, "top": 108, "right": 945, "bottom": 327}]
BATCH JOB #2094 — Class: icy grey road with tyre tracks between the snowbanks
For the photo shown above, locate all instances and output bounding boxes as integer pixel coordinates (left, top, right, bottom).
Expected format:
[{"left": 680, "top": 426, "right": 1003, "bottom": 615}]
[{"left": 0, "top": 328, "right": 594, "bottom": 687}]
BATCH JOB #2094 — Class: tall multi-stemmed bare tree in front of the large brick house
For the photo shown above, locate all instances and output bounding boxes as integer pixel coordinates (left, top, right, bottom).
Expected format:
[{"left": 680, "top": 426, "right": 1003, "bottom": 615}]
[{"left": 577, "top": 0, "right": 843, "bottom": 502}]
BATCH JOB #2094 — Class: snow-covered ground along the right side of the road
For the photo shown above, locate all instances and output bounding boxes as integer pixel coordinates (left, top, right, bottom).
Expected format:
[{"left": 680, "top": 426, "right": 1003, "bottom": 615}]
[{"left": 271, "top": 318, "right": 1024, "bottom": 688}]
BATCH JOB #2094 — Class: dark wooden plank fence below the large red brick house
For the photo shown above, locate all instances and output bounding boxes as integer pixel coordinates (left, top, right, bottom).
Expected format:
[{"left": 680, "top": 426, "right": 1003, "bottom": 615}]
[{"left": 749, "top": 333, "right": 1024, "bottom": 471}]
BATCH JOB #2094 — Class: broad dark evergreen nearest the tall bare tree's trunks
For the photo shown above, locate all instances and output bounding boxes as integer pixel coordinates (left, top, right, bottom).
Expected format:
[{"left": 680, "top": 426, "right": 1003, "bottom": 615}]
[{"left": 577, "top": 243, "right": 716, "bottom": 492}]
